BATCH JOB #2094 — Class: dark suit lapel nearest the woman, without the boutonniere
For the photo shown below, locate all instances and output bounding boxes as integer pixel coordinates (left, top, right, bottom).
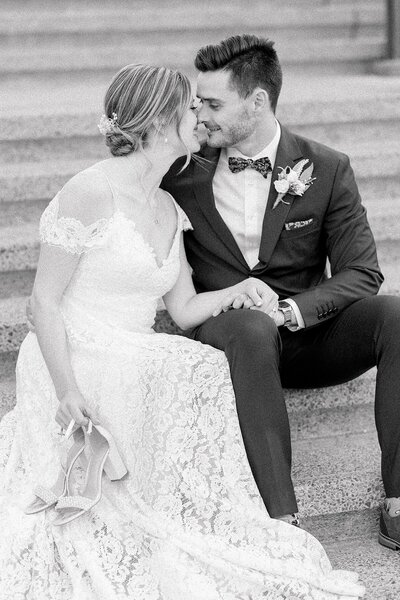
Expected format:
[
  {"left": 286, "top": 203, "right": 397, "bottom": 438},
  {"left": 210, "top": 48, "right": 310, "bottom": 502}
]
[{"left": 193, "top": 147, "right": 249, "bottom": 270}]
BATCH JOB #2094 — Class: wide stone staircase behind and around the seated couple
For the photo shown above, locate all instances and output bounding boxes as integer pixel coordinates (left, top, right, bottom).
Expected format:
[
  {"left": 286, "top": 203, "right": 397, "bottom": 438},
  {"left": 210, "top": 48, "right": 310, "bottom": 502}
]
[{"left": 0, "top": 0, "right": 400, "bottom": 600}]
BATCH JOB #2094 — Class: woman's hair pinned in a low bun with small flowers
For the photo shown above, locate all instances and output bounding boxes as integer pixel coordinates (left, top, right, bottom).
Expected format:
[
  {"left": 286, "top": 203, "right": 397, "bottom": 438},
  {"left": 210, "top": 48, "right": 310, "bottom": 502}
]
[{"left": 104, "top": 65, "right": 192, "bottom": 160}]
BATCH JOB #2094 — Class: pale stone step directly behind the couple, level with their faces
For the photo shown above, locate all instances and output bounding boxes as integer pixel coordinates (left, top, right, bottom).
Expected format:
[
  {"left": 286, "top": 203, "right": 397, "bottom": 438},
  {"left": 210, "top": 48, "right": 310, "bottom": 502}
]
[{"left": 0, "top": 71, "right": 400, "bottom": 139}]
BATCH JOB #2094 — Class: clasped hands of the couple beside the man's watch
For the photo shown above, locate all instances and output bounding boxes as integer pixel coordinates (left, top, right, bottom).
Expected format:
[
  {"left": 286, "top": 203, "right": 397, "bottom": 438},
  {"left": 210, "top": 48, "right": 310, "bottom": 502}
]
[{"left": 213, "top": 277, "right": 283, "bottom": 327}]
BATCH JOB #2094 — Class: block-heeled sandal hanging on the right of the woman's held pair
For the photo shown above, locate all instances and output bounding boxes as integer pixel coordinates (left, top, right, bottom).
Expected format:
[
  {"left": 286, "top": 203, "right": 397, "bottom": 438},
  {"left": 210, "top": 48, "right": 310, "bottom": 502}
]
[{"left": 53, "top": 422, "right": 128, "bottom": 525}]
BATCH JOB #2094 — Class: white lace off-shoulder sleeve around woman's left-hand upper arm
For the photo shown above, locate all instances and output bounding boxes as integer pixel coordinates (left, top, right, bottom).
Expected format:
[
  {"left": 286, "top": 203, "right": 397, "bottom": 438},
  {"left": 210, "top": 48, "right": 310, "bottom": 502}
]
[{"left": 39, "top": 196, "right": 110, "bottom": 254}]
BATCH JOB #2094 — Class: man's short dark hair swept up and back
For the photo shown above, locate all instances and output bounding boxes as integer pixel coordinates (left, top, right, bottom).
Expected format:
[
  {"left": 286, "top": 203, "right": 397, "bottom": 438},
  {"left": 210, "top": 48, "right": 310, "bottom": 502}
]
[{"left": 194, "top": 34, "right": 282, "bottom": 112}]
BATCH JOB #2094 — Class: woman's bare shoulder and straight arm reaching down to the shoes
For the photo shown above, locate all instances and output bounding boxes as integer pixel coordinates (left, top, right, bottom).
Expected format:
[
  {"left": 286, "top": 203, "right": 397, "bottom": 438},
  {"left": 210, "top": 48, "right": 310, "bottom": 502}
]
[{"left": 30, "top": 173, "right": 109, "bottom": 427}]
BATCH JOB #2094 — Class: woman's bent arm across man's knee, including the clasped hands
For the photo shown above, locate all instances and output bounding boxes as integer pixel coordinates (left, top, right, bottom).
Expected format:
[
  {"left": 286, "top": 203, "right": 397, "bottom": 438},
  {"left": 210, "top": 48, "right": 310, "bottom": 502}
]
[{"left": 163, "top": 236, "right": 278, "bottom": 329}]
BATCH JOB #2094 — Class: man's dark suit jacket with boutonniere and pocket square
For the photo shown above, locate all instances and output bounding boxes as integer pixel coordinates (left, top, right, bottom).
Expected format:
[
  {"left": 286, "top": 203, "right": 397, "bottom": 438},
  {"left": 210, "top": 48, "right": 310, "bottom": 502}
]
[{"left": 162, "top": 127, "right": 383, "bottom": 327}]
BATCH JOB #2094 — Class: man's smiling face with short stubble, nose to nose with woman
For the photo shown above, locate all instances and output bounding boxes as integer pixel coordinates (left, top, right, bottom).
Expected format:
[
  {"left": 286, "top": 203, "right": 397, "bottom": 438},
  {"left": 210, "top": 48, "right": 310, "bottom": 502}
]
[{"left": 197, "top": 71, "right": 256, "bottom": 148}]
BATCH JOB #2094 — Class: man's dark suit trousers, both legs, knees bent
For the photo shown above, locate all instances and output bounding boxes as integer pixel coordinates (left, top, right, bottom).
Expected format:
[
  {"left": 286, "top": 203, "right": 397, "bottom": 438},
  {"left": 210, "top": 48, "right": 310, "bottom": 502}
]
[{"left": 186, "top": 295, "right": 400, "bottom": 517}]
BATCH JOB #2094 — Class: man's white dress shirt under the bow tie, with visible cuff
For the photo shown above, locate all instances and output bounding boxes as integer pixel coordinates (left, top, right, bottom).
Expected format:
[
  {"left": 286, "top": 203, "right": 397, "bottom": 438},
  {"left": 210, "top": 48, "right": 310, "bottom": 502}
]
[{"left": 213, "top": 121, "right": 304, "bottom": 330}]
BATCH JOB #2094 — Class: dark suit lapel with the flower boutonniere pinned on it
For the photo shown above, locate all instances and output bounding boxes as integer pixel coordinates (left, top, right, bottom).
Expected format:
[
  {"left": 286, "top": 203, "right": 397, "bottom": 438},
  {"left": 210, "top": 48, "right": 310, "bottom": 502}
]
[{"left": 254, "top": 127, "right": 302, "bottom": 271}]
